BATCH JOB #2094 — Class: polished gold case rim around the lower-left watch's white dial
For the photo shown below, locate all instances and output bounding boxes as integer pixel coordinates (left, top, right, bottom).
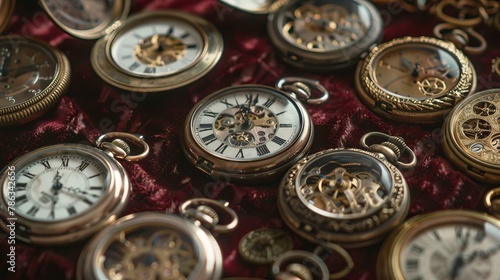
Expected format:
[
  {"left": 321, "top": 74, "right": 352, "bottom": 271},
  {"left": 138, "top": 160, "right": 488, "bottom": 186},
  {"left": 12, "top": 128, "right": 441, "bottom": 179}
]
[{"left": 0, "top": 144, "right": 131, "bottom": 245}]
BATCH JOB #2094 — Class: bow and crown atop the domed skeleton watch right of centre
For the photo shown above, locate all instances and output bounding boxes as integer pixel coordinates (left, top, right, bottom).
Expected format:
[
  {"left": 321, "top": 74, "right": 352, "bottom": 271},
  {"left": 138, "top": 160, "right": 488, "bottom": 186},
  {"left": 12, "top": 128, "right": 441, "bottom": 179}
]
[{"left": 359, "top": 132, "right": 417, "bottom": 169}]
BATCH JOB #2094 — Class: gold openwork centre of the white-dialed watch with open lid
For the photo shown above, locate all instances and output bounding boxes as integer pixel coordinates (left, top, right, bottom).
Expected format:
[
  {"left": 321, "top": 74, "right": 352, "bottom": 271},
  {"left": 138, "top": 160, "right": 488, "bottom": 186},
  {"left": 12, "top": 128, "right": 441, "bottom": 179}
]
[{"left": 135, "top": 34, "right": 187, "bottom": 67}]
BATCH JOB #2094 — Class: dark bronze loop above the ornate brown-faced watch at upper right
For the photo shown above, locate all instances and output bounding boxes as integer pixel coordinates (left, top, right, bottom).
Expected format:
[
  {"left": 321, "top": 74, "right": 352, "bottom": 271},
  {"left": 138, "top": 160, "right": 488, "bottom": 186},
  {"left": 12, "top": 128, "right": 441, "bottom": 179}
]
[{"left": 434, "top": 23, "right": 488, "bottom": 55}]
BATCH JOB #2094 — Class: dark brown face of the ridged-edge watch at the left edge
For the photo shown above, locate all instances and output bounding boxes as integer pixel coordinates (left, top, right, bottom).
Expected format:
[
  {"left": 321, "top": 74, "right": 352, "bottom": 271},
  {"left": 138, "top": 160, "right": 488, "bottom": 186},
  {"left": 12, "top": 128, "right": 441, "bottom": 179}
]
[{"left": 0, "top": 37, "right": 59, "bottom": 109}]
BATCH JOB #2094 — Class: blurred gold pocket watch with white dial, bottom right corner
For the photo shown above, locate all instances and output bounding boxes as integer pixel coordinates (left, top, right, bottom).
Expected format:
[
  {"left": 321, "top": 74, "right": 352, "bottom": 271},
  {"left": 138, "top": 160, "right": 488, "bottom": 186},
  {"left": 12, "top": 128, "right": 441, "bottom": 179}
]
[{"left": 377, "top": 210, "right": 500, "bottom": 280}]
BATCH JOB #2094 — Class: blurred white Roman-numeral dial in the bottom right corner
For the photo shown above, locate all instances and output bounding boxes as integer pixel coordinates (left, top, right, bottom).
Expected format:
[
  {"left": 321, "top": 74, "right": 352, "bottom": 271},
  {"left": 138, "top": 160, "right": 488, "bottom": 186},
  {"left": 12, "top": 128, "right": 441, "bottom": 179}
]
[{"left": 399, "top": 222, "right": 500, "bottom": 280}]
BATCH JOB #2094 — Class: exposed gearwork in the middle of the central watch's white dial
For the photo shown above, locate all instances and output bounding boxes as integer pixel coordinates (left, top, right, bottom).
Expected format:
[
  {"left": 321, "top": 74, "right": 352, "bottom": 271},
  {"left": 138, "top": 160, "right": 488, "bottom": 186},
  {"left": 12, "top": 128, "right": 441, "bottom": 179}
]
[{"left": 214, "top": 105, "right": 278, "bottom": 147}]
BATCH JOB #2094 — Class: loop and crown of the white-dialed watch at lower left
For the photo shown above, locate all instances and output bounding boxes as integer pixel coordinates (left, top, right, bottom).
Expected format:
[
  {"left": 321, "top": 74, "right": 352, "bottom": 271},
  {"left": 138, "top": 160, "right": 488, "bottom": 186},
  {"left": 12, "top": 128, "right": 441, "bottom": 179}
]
[{"left": 96, "top": 132, "right": 149, "bottom": 161}]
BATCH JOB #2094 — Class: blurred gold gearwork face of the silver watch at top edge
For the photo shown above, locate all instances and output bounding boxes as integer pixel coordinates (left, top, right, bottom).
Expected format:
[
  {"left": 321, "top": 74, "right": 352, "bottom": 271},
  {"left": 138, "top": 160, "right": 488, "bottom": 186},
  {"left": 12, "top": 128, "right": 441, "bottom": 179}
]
[{"left": 283, "top": 4, "right": 366, "bottom": 51}]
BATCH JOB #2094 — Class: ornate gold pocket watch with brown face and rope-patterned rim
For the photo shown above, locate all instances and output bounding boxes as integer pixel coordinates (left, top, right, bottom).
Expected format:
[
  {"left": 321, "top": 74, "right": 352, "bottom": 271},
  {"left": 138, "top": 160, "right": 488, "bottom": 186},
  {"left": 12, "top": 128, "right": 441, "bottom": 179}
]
[{"left": 355, "top": 37, "right": 477, "bottom": 124}]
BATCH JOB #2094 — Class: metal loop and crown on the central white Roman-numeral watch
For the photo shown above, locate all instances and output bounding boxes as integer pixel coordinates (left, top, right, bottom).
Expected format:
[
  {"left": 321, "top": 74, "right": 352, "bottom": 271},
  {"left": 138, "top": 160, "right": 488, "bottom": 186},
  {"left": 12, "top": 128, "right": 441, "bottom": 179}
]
[{"left": 276, "top": 77, "right": 329, "bottom": 105}]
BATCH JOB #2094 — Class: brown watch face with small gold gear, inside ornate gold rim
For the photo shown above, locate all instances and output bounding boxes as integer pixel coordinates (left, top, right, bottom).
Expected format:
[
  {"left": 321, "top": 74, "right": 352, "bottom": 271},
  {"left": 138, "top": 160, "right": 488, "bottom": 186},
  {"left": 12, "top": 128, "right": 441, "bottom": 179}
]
[{"left": 372, "top": 43, "right": 461, "bottom": 99}]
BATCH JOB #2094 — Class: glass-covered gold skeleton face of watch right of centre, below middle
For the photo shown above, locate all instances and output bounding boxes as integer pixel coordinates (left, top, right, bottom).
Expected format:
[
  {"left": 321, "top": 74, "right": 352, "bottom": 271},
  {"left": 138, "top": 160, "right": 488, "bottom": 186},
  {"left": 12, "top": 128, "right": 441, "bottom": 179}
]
[{"left": 296, "top": 150, "right": 394, "bottom": 219}]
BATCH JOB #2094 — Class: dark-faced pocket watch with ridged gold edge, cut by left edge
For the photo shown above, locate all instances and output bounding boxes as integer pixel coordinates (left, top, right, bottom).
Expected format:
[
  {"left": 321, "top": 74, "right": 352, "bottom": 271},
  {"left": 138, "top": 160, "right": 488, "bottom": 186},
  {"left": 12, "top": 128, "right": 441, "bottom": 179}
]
[{"left": 0, "top": 35, "right": 71, "bottom": 127}]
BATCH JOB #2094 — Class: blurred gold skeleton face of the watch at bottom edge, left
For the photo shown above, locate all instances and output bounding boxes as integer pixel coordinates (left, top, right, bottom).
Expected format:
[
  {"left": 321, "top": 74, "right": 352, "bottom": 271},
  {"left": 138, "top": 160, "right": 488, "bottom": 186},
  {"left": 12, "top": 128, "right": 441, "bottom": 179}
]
[{"left": 103, "top": 228, "right": 198, "bottom": 279}]
